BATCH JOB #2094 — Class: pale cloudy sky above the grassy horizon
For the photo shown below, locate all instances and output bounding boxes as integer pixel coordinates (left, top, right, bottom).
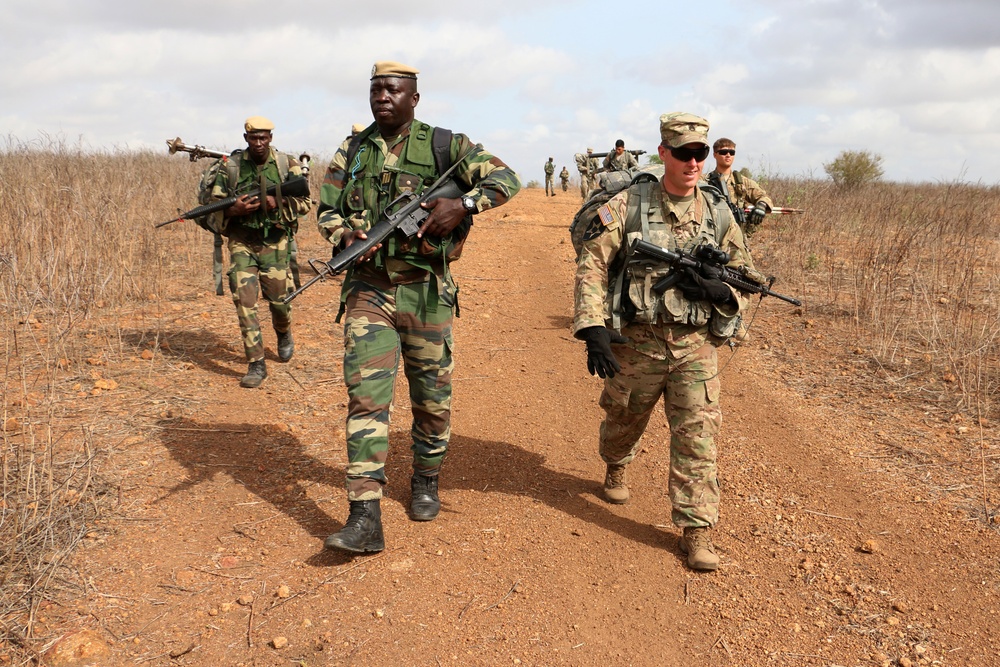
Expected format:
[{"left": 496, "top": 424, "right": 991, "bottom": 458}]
[{"left": 0, "top": 0, "right": 1000, "bottom": 186}]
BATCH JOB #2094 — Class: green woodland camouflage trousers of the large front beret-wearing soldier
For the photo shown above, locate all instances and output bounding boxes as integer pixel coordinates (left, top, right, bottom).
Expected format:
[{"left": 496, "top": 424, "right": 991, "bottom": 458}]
[{"left": 344, "top": 280, "right": 456, "bottom": 500}]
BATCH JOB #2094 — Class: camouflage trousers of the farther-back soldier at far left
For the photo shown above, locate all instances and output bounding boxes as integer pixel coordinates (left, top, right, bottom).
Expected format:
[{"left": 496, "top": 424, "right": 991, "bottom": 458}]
[{"left": 229, "top": 234, "right": 292, "bottom": 362}]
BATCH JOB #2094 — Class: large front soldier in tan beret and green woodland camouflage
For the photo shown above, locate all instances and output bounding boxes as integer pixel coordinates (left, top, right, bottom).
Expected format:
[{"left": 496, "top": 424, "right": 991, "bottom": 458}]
[{"left": 318, "top": 62, "right": 521, "bottom": 552}]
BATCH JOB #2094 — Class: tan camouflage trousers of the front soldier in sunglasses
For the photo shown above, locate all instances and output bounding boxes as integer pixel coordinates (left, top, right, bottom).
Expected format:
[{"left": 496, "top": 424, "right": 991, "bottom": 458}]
[{"left": 600, "top": 343, "right": 722, "bottom": 527}]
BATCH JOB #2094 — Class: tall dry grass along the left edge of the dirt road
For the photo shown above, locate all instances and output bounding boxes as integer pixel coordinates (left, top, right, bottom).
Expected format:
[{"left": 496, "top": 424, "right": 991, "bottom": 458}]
[{"left": 0, "top": 139, "right": 207, "bottom": 653}]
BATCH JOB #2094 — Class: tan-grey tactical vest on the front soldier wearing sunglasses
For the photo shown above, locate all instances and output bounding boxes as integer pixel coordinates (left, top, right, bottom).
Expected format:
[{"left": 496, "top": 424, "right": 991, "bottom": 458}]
[{"left": 610, "top": 177, "right": 739, "bottom": 338}]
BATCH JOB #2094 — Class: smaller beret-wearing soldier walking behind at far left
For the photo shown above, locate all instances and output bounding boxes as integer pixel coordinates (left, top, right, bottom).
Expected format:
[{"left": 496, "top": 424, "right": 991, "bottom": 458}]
[{"left": 212, "top": 116, "right": 312, "bottom": 388}]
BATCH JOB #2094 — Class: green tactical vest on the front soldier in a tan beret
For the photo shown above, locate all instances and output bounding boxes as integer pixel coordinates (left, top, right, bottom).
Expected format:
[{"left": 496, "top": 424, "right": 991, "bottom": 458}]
[{"left": 344, "top": 121, "right": 472, "bottom": 272}]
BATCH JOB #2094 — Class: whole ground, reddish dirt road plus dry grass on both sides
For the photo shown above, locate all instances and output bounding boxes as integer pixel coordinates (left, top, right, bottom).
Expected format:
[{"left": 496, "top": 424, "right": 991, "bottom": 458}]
[{"left": 0, "top": 143, "right": 1000, "bottom": 665}]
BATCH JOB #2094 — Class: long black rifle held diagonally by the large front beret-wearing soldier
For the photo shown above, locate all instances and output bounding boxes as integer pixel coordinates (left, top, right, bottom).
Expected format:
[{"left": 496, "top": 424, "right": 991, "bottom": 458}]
[{"left": 281, "top": 151, "right": 471, "bottom": 303}]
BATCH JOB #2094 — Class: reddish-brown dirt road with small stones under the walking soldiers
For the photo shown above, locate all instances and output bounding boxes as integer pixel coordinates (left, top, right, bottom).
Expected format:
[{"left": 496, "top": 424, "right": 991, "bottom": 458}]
[{"left": 56, "top": 189, "right": 1000, "bottom": 667}]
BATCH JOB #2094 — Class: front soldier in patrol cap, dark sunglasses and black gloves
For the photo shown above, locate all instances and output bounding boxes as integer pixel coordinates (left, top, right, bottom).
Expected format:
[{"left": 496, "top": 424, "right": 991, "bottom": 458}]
[{"left": 573, "top": 113, "right": 752, "bottom": 570}]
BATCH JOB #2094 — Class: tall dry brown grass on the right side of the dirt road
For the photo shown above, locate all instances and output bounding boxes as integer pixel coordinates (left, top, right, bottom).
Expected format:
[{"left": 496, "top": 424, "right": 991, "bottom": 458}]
[{"left": 762, "top": 180, "right": 1000, "bottom": 415}]
